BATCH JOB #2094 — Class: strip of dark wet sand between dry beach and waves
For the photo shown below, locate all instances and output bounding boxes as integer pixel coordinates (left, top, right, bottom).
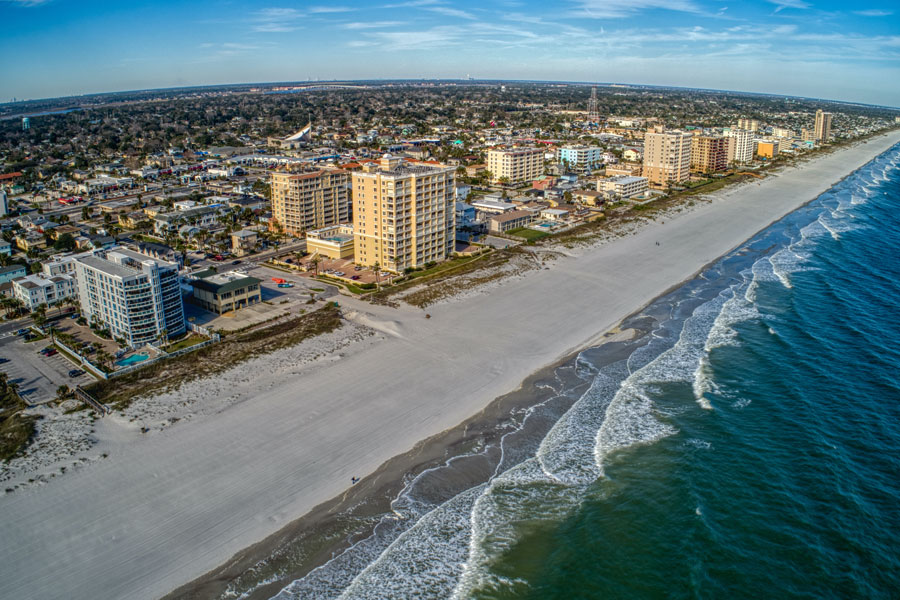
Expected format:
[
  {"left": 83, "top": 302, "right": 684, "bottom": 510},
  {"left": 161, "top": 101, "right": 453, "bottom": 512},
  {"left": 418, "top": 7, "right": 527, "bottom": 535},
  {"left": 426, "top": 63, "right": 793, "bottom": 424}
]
[{"left": 171, "top": 136, "right": 900, "bottom": 600}]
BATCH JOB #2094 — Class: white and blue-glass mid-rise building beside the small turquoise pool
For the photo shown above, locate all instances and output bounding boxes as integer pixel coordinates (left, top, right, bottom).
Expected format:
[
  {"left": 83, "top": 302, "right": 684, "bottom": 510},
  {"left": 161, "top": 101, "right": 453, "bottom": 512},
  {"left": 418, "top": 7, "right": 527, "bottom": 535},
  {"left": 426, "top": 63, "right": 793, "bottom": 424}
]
[{"left": 75, "top": 248, "right": 185, "bottom": 347}]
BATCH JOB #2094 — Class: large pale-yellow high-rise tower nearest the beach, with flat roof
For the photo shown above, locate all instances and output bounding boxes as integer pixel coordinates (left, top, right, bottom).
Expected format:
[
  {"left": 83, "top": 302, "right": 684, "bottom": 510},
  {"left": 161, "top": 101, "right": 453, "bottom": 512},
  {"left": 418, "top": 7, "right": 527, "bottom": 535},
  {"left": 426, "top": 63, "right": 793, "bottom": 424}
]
[{"left": 353, "top": 155, "right": 456, "bottom": 272}]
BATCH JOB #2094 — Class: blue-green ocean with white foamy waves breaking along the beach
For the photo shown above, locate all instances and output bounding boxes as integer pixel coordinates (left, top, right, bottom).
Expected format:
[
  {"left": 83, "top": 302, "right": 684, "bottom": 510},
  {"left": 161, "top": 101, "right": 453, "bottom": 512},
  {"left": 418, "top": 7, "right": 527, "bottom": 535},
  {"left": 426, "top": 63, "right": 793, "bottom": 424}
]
[{"left": 246, "top": 145, "right": 900, "bottom": 600}]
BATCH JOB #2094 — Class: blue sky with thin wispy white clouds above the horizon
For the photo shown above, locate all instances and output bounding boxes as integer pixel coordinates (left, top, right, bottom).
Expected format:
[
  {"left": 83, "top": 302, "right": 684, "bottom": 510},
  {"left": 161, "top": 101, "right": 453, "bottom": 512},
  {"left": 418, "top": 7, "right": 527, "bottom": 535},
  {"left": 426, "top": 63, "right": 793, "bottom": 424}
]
[{"left": 0, "top": 0, "right": 900, "bottom": 107}]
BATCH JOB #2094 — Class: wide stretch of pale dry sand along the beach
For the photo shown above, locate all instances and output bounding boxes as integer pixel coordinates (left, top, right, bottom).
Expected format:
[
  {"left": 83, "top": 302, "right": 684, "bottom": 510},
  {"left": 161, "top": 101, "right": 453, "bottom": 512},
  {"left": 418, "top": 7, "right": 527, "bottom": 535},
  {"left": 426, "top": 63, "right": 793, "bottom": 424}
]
[{"left": 0, "top": 133, "right": 900, "bottom": 599}]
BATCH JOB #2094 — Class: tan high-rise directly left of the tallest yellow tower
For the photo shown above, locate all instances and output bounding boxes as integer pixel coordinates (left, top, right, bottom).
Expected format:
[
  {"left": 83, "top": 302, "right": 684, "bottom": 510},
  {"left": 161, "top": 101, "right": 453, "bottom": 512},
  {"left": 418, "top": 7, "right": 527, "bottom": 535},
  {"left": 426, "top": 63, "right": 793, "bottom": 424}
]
[{"left": 272, "top": 169, "right": 350, "bottom": 235}]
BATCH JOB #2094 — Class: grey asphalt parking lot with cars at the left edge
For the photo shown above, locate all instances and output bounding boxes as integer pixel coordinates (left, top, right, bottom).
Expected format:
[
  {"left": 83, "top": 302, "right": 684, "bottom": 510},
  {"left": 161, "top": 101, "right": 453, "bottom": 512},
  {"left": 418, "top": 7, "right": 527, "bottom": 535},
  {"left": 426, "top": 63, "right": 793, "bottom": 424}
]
[{"left": 0, "top": 335, "right": 94, "bottom": 404}]
